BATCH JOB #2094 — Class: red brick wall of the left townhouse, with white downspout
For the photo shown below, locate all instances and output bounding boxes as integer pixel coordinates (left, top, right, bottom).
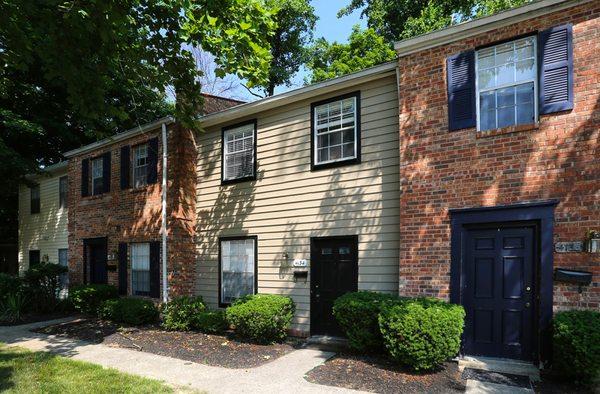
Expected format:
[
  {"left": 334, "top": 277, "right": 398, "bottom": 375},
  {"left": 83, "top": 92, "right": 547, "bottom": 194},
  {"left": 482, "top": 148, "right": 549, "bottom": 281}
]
[{"left": 68, "top": 125, "right": 195, "bottom": 293}]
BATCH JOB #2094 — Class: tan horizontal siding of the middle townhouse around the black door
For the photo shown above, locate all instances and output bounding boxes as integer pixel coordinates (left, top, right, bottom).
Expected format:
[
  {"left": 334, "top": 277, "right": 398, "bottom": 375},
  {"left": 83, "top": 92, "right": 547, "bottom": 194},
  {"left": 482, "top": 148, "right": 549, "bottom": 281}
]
[{"left": 197, "top": 77, "right": 400, "bottom": 332}]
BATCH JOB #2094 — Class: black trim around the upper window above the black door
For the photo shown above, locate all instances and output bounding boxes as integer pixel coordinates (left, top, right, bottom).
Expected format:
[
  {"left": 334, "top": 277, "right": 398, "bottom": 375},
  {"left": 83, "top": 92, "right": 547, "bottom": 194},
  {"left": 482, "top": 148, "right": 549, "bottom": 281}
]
[{"left": 310, "top": 90, "right": 362, "bottom": 171}]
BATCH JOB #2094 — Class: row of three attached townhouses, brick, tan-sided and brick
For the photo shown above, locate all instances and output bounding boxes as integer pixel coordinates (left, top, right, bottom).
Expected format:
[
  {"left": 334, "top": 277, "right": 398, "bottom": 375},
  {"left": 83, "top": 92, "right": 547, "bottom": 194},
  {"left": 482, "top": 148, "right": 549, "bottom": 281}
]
[{"left": 23, "top": 0, "right": 600, "bottom": 363}]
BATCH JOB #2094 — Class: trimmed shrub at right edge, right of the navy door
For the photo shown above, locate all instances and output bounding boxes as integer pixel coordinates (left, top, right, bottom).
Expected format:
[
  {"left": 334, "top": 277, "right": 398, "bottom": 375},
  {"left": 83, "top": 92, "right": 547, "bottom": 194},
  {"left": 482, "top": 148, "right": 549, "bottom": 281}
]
[{"left": 553, "top": 311, "right": 600, "bottom": 384}]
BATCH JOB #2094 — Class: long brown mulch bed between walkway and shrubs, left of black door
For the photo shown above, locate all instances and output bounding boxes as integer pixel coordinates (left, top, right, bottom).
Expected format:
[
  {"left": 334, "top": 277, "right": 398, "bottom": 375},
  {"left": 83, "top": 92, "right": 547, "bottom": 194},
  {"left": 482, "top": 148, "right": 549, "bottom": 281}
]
[{"left": 36, "top": 319, "right": 301, "bottom": 368}]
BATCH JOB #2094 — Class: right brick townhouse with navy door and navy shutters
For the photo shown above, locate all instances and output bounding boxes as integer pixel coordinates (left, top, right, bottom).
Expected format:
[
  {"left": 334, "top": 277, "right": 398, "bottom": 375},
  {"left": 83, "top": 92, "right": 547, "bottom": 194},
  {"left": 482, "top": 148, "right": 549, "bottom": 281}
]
[{"left": 395, "top": 0, "right": 600, "bottom": 361}]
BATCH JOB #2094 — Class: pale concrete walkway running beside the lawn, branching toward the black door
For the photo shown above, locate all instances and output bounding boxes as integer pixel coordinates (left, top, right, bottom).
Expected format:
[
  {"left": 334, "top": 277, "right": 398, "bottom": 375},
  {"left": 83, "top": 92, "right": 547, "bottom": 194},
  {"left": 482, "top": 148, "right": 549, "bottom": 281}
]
[{"left": 0, "top": 319, "right": 359, "bottom": 394}]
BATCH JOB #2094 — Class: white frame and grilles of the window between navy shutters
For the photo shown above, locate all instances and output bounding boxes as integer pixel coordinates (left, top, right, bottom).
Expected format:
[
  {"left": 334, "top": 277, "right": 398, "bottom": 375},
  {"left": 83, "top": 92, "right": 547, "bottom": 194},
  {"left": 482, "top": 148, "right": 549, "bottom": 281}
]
[{"left": 475, "top": 36, "right": 539, "bottom": 132}]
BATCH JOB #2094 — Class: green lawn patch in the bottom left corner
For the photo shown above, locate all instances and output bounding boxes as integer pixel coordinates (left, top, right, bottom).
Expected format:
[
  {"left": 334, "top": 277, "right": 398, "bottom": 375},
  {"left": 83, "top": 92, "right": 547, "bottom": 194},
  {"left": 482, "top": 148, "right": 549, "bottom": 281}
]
[{"left": 0, "top": 344, "right": 174, "bottom": 394}]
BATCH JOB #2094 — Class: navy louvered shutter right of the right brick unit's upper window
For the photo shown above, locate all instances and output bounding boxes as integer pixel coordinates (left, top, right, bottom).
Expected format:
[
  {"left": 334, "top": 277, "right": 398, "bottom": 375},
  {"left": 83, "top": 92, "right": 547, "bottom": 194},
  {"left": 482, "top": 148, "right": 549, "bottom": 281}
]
[{"left": 538, "top": 24, "right": 573, "bottom": 114}]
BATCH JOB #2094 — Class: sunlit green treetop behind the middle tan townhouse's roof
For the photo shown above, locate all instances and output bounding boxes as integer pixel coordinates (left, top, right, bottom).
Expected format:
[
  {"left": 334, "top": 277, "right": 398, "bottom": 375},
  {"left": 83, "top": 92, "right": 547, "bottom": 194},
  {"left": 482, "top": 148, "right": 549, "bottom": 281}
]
[{"left": 306, "top": 25, "right": 396, "bottom": 83}]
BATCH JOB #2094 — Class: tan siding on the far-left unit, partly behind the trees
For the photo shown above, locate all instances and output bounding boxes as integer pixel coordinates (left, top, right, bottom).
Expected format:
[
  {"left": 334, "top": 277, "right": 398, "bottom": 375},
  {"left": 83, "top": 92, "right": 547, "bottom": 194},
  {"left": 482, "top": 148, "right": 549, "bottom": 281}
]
[{"left": 19, "top": 171, "right": 68, "bottom": 272}]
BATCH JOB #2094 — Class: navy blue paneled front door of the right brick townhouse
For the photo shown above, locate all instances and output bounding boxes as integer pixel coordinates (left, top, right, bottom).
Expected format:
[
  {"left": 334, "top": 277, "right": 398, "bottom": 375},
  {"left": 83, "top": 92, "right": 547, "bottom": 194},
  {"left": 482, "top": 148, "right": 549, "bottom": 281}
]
[{"left": 462, "top": 226, "right": 537, "bottom": 360}]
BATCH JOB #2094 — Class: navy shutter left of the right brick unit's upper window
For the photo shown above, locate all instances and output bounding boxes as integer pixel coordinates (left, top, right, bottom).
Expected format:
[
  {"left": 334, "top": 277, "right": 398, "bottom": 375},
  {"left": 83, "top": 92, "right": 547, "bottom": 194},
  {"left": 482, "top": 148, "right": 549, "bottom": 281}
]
[{"left": 446, "top": 51, "right": 477, "bottom": 131}]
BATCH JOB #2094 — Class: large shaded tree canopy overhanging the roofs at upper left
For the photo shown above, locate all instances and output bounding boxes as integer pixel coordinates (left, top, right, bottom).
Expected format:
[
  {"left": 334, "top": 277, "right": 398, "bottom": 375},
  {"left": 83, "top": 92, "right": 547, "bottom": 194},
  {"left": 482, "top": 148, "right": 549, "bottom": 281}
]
[{"left": 0, "top": 0, "right": 275, "bottom": 239}]
